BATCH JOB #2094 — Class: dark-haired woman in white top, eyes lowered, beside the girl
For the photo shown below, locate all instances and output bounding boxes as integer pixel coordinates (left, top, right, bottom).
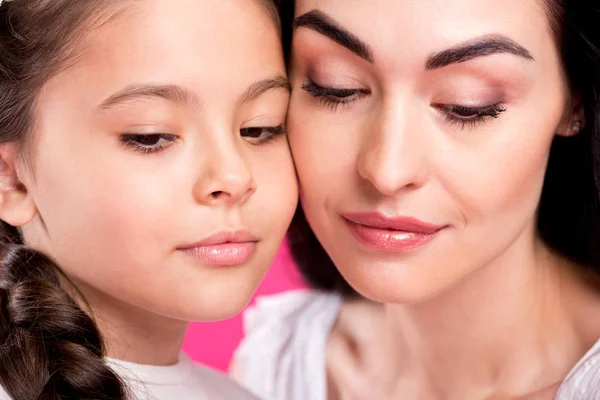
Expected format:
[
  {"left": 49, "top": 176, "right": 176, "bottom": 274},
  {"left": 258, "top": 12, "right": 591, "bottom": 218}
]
[{"left": 236, "top": 0, "right": 600, "bottom": 400}]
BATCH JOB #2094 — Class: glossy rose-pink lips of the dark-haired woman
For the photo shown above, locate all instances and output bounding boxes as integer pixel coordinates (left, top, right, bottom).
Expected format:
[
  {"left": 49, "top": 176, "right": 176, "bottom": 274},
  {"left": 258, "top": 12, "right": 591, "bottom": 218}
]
[{"left": 342, "top": 213, "right": 445, "bottom": 252}]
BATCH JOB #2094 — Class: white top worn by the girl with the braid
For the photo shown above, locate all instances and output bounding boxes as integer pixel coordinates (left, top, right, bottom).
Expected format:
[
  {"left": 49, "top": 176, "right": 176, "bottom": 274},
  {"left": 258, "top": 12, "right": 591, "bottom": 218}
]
[{"left": 0, "top": 354, "right": 258, "bottom": 400}]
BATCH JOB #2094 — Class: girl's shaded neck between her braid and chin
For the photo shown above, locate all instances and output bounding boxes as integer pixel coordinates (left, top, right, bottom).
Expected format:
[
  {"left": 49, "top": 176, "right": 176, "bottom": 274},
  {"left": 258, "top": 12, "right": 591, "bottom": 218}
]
[{"left": 77, "top": 284, "right": 189, "bottom": 365}]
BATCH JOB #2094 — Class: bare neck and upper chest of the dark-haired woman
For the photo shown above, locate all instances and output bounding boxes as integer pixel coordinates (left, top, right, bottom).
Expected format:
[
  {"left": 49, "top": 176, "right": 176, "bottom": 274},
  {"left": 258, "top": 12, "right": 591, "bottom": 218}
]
[{"left": 383, "top": 228, "right": 588, "bottom": 399}]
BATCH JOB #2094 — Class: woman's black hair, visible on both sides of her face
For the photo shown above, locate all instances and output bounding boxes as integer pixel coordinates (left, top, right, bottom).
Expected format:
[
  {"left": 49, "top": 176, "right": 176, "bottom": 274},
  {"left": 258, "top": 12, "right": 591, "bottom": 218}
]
[{"left": 281, "top": 0, "right": 600, "bottom": 296}]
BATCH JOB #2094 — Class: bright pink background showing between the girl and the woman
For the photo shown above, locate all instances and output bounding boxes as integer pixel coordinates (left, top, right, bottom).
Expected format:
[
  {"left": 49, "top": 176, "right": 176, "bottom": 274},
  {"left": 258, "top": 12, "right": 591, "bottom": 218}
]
[{"left": 183, "top": 241, "right": 302, "bottom": 371}]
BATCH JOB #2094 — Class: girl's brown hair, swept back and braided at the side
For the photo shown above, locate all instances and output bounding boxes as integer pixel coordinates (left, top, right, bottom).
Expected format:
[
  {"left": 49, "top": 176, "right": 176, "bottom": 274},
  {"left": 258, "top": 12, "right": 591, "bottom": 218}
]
[{"left": 0, "top": 0, "right": 273, "bottom": 400}]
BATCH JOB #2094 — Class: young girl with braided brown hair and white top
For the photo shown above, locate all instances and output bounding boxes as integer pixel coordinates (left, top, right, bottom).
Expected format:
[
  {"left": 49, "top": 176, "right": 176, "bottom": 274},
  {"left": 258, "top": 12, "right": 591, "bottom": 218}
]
[{"left": 0, "top": 0, "right": 297, "bottom": 400}]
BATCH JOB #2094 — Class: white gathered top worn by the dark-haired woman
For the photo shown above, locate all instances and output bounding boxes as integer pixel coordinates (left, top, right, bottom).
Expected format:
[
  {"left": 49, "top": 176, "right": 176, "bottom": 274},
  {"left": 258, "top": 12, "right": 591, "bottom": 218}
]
[{"left": 235, "top": 291, "right": 600, "bottom": 400}]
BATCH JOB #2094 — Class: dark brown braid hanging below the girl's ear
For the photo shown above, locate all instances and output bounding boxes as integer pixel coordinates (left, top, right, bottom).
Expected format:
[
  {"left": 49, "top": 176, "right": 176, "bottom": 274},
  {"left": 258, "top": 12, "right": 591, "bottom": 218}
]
[{"left": 0, "top": 224, "right": 125, "bottom": 400}]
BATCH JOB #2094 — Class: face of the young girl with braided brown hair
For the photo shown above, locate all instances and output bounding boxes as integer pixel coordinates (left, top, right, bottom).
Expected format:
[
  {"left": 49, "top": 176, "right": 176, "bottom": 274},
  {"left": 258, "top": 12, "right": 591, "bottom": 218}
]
[{"left": 15, "top": 0, "right": 297, "bottom": 320}]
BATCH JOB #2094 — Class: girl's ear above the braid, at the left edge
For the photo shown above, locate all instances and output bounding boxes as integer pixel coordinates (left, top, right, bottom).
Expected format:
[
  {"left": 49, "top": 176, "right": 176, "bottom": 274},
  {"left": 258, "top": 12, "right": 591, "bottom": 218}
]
[{"left": 0, "top": 143, "right": 37, "bottom": 226}]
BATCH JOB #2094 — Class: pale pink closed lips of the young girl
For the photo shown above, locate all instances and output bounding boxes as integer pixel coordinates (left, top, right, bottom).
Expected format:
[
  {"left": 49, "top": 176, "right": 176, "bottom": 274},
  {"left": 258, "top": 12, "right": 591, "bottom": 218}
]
[{"left": 178, "top": 230, "right": 258, "bottom": 266}]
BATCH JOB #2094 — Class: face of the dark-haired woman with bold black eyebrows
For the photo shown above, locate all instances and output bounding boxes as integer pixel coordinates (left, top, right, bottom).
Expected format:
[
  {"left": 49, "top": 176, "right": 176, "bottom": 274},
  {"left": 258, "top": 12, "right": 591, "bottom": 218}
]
[{"left": 288, "top": 0, "right": 575, "bottom": 303}]
